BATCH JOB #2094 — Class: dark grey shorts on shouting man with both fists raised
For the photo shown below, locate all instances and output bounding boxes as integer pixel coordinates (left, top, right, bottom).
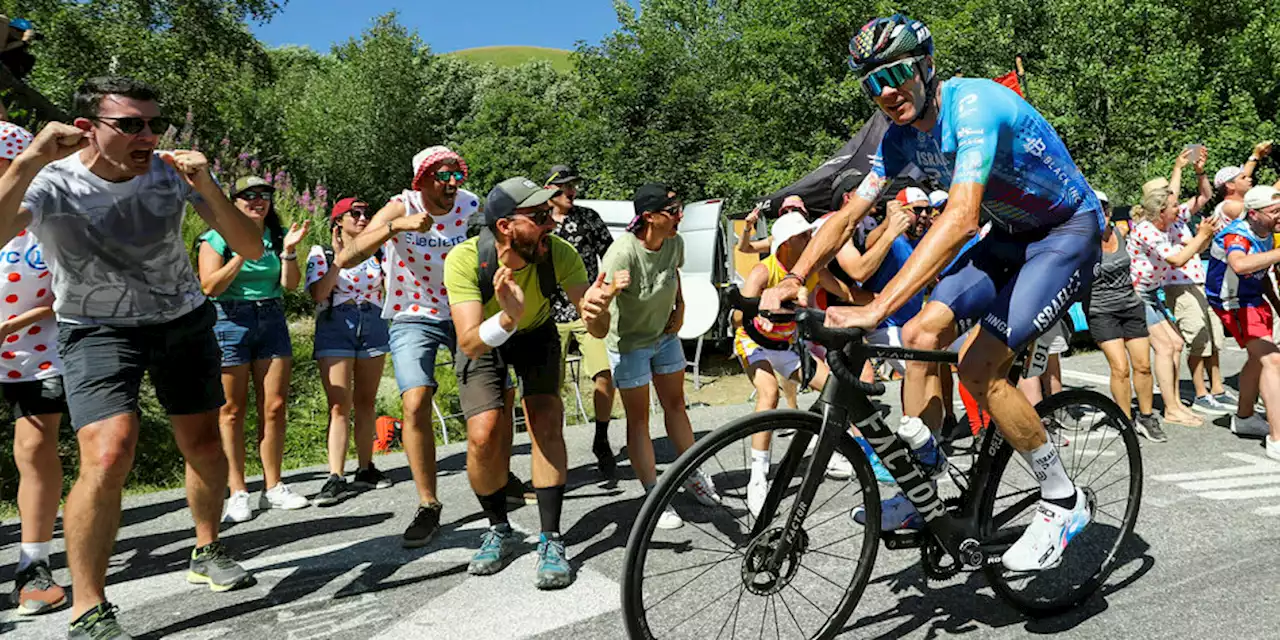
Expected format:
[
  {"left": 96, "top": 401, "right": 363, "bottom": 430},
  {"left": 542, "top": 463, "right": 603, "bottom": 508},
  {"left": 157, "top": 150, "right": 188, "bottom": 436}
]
[{"left": 58, "top": 302, "right": 225, "bottom": 430}]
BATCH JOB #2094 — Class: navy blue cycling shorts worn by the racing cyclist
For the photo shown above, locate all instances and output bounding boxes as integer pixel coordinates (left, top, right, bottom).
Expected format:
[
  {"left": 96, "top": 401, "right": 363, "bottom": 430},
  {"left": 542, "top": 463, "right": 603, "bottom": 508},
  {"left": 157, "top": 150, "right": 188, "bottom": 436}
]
[{"left": 929, "top": 210, "right": 1102, "bottom": 352}]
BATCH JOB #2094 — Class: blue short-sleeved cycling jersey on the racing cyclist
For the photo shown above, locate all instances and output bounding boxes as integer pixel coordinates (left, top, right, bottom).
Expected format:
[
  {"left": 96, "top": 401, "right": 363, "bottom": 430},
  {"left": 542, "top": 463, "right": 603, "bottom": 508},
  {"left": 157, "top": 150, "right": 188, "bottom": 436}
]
[{"left": 858, "top": 78, "right": 1103, "bottom": 232}]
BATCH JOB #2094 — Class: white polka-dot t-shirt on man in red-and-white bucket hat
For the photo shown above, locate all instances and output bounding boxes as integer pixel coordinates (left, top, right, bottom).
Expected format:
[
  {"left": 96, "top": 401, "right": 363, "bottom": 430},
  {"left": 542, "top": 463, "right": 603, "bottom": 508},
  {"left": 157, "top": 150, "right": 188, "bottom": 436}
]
[{"left": 383, "top": 189, "right": 480, "bottom": 320}]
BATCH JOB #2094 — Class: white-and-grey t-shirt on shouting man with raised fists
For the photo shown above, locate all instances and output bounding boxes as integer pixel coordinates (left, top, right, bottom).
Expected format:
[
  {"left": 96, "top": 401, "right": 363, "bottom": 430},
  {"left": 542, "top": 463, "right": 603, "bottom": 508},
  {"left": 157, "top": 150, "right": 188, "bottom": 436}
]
[{"left": 22, "top": 154, "right": 205, "bottom": 326}]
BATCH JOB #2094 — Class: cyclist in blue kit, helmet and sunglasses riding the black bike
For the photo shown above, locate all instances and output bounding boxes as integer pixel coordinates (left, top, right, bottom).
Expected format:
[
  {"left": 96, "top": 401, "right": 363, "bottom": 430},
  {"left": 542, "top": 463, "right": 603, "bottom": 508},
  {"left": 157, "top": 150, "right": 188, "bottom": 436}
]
[{"left": 764, "top": 14, "right": 1102, "bottom": 571}]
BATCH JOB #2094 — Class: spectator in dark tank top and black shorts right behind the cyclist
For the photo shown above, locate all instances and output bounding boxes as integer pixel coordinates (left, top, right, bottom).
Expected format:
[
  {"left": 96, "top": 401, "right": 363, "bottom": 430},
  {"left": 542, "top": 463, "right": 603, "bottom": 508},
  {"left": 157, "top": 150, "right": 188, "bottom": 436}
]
[{"left": 1084, "top": 191, "right": 1167, "bottom": 442}]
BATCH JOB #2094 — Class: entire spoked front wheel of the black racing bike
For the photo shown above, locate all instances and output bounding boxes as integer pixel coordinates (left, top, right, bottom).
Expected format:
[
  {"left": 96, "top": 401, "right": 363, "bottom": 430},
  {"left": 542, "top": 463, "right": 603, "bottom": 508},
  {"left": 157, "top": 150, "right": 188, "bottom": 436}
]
[{"left": 622, "top": 410, "right": 879, "bottom": 640}]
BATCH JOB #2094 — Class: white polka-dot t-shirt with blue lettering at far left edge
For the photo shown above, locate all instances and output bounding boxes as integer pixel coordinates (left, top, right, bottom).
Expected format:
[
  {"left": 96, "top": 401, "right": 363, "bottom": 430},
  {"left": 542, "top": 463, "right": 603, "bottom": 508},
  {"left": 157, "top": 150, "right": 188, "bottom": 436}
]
[{"left": 0, "top": 230, "right": 63, "bottom": 383}]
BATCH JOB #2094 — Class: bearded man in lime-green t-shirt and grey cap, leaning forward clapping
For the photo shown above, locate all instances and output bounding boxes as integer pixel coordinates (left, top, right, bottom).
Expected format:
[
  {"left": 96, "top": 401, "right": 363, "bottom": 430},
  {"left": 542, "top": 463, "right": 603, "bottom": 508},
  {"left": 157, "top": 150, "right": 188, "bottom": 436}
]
[{"left": 444, "top": 178, "right": 627, "bottom": 589}]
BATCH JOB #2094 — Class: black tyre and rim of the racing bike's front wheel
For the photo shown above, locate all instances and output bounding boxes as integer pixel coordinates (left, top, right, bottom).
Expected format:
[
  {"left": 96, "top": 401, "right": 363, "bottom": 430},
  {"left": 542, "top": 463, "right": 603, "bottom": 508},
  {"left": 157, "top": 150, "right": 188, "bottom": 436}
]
[{"left": 621, "top": 410, "right": 879, "bottom": 640}]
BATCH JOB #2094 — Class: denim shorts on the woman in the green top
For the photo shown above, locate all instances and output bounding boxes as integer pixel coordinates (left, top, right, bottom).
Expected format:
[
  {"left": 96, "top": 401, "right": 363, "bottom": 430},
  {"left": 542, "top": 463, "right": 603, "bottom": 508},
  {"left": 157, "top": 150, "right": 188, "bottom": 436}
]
[{"left": 214, "top": 298, "right": 293, "bottom": 367}]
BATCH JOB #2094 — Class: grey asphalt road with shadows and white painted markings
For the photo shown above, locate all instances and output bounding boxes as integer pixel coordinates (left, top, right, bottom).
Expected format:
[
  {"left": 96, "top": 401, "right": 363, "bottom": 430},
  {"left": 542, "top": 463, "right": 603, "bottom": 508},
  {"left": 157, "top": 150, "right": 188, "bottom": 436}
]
[{"left": 0, "top": 349, "right": 1280, "bottom": 640}]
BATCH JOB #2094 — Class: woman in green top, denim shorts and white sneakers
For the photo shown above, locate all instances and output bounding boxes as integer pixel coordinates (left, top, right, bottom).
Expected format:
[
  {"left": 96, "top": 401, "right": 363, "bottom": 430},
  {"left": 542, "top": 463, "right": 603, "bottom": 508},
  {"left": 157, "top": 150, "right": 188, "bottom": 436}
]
[{"left": 197, "top": 177, "right": 311, "bottom": 522}]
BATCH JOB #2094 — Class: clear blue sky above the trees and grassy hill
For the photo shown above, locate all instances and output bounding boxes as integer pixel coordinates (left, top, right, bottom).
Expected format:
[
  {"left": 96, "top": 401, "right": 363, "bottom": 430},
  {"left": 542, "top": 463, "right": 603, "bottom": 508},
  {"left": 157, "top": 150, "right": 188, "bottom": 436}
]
[{"left": 250, "top": 0, "right": 639, "bottom": 52}]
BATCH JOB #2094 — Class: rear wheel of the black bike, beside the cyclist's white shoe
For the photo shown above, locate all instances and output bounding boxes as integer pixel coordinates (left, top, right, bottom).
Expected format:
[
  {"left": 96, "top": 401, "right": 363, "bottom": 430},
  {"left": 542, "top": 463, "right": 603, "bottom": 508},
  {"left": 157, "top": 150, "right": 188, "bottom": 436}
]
[{"left": 978, "top": 389, "right": 1142, "bottom": 617}]
